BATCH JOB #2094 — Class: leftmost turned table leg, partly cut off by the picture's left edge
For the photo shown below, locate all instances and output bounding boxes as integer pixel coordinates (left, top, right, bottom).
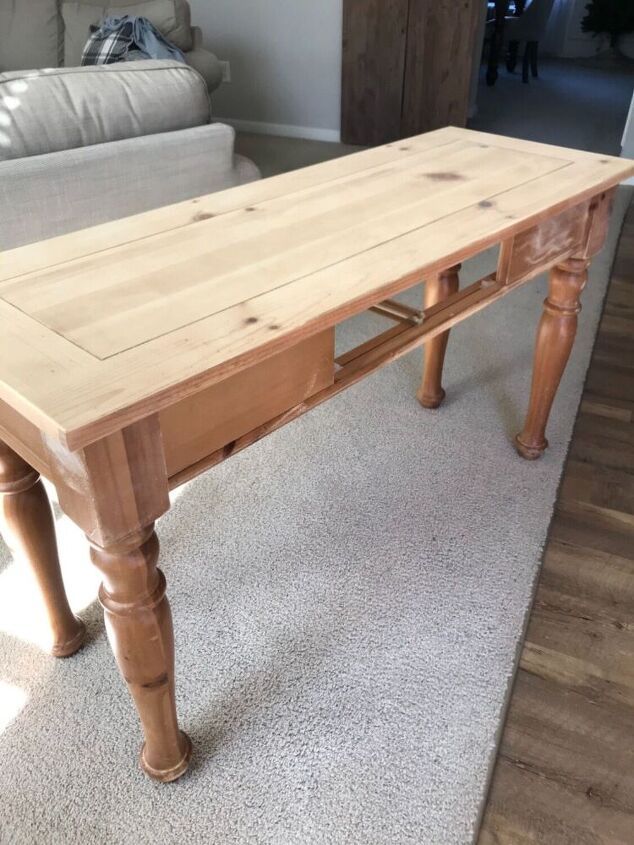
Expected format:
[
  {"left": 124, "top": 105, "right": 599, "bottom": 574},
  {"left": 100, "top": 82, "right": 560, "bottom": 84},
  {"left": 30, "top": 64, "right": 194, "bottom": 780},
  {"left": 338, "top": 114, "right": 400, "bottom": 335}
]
[{"left": 0, "top": 441, "right": 86, "bottom": 657}]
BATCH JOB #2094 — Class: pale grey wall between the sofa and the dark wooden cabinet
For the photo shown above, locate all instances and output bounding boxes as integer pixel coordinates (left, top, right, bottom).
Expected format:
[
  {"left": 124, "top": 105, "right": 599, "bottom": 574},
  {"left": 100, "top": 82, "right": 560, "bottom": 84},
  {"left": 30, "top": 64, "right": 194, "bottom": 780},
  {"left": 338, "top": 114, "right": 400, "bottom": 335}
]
[{"left": 190, "top": 0, "right": 342, "bottom": 140}]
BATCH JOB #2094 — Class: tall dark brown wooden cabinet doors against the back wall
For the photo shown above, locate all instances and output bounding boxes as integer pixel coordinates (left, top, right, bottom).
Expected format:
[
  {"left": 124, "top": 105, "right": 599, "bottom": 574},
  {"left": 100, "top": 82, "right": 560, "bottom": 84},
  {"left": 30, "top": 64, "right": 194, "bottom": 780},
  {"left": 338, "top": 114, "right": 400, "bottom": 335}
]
[{"left": 341, "top": 0, "right": 478, "bottom": 145}]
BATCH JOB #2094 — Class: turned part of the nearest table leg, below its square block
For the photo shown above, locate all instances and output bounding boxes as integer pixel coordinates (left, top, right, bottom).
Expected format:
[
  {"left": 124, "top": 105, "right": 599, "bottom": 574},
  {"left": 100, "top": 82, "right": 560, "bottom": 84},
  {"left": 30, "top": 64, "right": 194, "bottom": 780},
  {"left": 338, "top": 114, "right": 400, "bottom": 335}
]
[{"left": 91, "top": 525, "right": 192, "bottom": 782}]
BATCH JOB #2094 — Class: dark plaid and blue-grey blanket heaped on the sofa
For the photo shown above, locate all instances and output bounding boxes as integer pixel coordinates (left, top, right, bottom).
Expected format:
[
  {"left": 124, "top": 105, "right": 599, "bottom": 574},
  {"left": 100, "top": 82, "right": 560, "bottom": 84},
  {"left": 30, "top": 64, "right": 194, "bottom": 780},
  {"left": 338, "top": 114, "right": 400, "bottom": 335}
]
[{"left": 81, "top": 15, "right": 185, "bottom": 65}]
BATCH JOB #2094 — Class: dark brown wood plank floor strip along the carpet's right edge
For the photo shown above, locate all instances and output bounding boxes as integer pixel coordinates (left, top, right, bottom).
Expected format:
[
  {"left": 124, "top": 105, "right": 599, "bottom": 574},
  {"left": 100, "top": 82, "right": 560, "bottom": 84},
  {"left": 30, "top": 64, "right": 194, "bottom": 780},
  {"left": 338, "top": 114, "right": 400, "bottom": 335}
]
[{"left": 479, "top": 201, "right": 634, "bottom": 845}]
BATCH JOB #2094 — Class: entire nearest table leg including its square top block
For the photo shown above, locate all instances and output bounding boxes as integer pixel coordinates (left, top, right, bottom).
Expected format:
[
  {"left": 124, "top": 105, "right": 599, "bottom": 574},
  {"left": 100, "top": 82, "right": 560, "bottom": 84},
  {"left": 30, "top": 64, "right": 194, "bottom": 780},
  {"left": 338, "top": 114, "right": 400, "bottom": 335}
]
[{"left": 46, "top": 414, "right": 191, "bottom": 782}]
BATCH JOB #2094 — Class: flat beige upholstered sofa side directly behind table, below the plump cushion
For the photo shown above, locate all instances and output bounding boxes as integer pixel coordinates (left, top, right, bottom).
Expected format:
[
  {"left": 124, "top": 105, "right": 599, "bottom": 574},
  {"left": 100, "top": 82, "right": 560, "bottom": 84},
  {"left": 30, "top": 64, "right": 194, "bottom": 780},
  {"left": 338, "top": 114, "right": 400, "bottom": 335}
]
[{"left": 0, "top": 123, "right": 259, "bottom": 250}]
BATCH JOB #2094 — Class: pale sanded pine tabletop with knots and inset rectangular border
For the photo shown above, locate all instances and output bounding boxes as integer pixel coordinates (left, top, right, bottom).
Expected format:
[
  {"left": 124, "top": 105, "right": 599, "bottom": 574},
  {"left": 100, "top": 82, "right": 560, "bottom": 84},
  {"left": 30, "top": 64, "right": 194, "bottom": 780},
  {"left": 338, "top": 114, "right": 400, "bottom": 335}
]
[{"left": 0, "top": 128, "right": 634, "bottom": 448}]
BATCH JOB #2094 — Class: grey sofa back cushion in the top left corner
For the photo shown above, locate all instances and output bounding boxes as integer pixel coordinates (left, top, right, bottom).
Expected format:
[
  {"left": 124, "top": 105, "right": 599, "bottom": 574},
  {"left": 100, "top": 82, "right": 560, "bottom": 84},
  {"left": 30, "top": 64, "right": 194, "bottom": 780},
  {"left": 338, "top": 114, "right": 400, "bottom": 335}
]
[{"left": 0, "top": 0, "right": 63, "bottom": 71}]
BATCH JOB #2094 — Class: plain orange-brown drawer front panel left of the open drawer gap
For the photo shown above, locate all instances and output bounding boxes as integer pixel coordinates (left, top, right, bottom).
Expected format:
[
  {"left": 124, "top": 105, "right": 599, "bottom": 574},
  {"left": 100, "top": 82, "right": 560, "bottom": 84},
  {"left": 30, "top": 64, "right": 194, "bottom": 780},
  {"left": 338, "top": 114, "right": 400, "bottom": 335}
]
[{"left": 159, "top": 329, "right": 334, "bottom": 477}]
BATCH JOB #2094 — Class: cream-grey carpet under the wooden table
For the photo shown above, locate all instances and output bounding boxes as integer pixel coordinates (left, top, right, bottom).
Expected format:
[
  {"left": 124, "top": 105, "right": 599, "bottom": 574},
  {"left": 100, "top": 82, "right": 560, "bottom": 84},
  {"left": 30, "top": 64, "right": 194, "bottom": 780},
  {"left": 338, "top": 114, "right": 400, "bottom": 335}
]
[{"left": 0, "top": 191, "right": 629, "bottom": 845}]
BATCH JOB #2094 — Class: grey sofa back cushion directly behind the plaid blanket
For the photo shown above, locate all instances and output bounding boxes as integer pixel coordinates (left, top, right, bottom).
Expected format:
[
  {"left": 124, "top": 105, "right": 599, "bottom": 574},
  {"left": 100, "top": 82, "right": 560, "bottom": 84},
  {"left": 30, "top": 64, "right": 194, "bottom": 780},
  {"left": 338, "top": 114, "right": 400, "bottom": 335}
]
[{"left": 62, "top": 0, "right": 192, "bottom": 67}]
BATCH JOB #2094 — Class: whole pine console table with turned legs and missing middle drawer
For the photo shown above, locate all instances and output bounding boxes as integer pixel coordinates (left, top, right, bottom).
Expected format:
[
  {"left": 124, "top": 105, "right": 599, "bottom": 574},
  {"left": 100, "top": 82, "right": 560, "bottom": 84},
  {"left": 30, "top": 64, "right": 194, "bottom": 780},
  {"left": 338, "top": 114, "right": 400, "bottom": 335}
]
[{"left": 0, "top": 128, "right": 634, "bottom": 781}]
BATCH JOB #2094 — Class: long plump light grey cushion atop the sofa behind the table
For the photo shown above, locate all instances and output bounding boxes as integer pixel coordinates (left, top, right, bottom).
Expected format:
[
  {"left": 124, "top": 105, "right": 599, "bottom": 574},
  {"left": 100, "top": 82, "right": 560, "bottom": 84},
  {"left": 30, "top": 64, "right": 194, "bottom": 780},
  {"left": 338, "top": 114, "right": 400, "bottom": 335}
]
[{"left": 0, "top": 60, "right": 211, "bottom": 162}]
